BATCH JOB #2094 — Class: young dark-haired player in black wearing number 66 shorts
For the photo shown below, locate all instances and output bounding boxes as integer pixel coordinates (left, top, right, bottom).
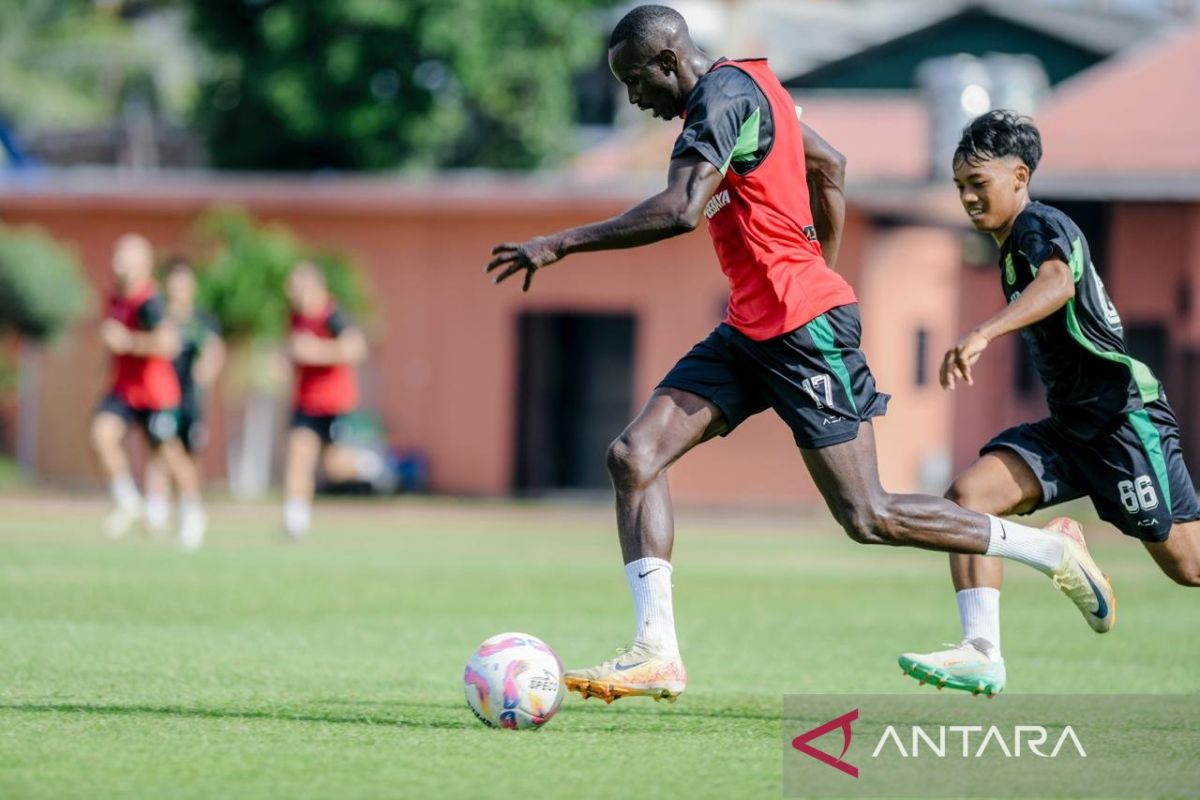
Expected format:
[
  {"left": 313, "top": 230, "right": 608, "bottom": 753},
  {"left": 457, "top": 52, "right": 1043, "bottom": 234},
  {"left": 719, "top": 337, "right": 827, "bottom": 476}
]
[{"left": 900, "top": 110, "right": 1200, "bottom": 693}]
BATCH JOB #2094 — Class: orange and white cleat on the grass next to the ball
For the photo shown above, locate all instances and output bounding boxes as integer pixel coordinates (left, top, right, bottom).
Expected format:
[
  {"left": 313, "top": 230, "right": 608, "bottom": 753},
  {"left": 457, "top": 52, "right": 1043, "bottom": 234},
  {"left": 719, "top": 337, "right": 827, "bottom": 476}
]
[{"left": 563, "top": 642, "right": 688, "bottom": 703}]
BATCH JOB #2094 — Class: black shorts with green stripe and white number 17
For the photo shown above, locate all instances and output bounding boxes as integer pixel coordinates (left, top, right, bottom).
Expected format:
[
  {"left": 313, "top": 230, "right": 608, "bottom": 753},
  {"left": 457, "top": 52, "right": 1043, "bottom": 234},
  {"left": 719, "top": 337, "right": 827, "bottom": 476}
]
[{"left": 659, "top": 303, "right": 889, "bottom": 450}]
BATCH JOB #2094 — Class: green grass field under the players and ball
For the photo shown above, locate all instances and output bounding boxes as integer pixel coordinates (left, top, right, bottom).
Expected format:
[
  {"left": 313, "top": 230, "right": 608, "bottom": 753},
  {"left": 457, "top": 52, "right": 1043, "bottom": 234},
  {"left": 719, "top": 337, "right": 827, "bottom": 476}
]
[{"left": 0, "top": 498, "right": 1200, "bottom": 800}]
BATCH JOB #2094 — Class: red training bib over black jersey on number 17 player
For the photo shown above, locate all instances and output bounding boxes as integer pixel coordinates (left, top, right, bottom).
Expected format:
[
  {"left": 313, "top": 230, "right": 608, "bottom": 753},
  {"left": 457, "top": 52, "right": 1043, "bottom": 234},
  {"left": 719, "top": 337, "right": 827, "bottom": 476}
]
[{"left": 672, "top": 59, "right": 856, "bottom": 341}]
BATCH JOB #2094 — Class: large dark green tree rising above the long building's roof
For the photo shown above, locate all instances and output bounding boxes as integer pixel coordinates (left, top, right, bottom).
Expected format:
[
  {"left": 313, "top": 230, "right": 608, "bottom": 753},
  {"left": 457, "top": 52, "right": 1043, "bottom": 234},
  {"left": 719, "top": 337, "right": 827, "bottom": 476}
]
[{"left": 192, "top": 0, "right": 614, "bottom": 170}]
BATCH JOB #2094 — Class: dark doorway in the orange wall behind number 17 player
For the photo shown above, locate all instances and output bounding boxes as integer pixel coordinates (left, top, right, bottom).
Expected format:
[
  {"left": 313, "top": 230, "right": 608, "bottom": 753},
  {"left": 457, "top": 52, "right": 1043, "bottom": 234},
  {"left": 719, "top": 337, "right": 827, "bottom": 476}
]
[{"left": 516, "top": 313, "right": 635, "bottom": 494}]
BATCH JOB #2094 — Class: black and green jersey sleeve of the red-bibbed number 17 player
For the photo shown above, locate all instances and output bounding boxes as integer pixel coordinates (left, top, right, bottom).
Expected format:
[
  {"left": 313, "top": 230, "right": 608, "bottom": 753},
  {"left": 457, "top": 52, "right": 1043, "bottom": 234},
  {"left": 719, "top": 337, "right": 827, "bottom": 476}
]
[{"left": 671, "top": 59, "right": 775, "bottom": 175}]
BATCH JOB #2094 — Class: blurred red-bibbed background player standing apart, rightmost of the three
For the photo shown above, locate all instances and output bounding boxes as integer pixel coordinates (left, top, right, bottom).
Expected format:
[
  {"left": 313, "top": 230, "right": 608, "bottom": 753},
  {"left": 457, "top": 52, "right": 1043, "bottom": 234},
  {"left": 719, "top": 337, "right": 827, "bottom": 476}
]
[{"left": 283, "top": 261, "right": 367, "bottom": 539}]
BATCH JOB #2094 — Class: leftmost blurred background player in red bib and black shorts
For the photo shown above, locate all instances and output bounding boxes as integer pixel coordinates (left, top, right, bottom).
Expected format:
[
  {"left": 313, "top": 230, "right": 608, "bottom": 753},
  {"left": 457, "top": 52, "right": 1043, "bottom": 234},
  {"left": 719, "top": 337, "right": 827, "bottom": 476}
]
[{"left": 91, "top": 234, "right": 205, "bottom": 549}]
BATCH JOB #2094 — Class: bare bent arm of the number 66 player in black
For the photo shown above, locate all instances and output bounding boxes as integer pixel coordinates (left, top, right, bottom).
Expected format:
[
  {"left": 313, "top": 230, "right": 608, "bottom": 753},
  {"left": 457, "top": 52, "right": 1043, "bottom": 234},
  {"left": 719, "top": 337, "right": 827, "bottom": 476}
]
[{"left": 940, "top": 258, "right": 1075, "bottom": 389}]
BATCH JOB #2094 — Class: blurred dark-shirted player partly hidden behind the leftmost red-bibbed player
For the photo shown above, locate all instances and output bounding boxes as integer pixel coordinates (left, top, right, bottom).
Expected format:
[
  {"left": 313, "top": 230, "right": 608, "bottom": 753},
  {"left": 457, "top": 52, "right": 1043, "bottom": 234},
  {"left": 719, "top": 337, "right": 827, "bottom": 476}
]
[{"left": 145, "top": 258, "right": 226, "bottom": 533}]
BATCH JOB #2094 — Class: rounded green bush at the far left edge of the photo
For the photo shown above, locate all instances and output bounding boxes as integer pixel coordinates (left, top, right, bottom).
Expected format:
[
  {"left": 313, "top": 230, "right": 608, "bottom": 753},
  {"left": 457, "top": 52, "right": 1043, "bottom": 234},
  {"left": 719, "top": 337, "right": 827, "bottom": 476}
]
[{"left": 0, "top": 224, "right": 91, "bottom": 339}]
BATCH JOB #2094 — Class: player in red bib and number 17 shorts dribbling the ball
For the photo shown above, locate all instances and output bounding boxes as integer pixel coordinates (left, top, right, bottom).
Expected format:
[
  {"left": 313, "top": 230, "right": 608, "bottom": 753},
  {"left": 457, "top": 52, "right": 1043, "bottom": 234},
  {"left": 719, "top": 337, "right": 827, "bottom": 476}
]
[{"left": 486, "top": 6, "right": 1112, "bottom": 702}]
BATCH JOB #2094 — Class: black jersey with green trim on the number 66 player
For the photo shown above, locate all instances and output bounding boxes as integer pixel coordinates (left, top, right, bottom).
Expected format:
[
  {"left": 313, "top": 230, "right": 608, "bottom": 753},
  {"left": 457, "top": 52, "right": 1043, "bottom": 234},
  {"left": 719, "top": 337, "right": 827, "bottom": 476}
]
[{"left": 1000, "top": 203, "right": 1162, "bottom": 440}]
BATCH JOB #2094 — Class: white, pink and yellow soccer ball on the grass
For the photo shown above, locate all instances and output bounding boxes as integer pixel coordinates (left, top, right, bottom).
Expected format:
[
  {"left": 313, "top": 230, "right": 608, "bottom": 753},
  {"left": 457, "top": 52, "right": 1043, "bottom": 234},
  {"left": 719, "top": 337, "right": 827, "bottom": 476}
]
[{"left": 462, "top": 632, "right": 564, "bottom": 730}]
